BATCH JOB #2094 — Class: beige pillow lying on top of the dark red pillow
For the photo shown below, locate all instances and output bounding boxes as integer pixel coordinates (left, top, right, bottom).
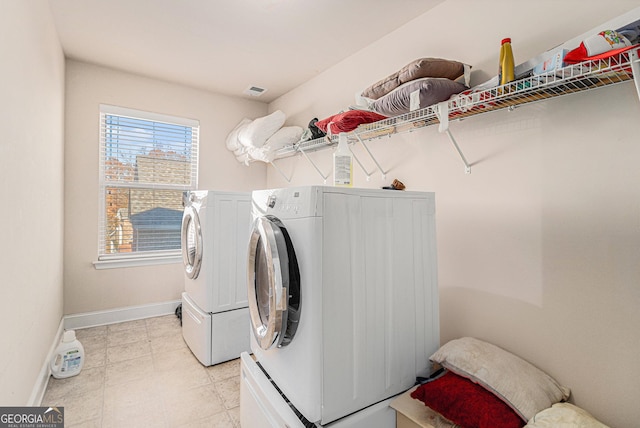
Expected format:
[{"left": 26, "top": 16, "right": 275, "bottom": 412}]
[{"left": 430, "top": 337, "right": 571, "bottom": 421}]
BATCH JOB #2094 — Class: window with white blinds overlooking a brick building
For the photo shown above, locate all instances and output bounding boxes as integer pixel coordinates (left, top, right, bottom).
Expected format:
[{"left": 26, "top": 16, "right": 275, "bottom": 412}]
[{"left": 96, "top": 105, "right": 199, "bottom": 267}]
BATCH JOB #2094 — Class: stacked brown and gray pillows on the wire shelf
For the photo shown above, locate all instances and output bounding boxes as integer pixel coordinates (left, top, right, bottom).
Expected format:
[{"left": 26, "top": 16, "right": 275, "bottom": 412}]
[{"left": 356, "top": 58, "right": 470, "bottom": 117}]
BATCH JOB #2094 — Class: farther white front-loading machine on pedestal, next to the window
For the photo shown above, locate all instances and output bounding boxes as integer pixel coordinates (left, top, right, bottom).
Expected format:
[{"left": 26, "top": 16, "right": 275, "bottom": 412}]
[{"left": 181, "top": 190, "right": 251, "bottom": 366}]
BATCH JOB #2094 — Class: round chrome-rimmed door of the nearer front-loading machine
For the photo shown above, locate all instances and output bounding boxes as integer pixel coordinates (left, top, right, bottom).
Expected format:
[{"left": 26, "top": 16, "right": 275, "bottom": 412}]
[{"left": 247, "top": 216, "right": 300, "bottom": 349}]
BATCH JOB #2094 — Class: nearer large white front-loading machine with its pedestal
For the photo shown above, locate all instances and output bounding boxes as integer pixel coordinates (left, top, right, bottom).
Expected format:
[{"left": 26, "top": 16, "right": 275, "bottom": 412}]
[{"left": 240, "top": 186, "right": 440, "bottom": 428}]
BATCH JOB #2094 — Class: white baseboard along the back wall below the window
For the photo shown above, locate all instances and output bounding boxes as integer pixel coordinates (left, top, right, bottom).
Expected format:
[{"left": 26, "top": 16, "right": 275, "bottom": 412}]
[{"left": 64, "top": 300, "right": 181, "bottom": 330}]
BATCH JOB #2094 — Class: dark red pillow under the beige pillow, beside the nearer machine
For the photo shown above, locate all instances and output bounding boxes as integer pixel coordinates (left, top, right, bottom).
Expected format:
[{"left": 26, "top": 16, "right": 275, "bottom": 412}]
[{"left": 411, "top": 372, "right": 525, "bottom": 428}]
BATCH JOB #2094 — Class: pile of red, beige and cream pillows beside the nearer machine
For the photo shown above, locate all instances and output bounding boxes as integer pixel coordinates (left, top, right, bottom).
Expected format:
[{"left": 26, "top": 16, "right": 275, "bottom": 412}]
[{"left": 411, "top": 337, "right": 607, "bottom": 428}]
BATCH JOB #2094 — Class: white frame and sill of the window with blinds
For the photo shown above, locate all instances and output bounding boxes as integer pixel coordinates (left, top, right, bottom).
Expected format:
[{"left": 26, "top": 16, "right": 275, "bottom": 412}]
[{"left": 93, "top": 104, "right": 200, "bottom": 269}]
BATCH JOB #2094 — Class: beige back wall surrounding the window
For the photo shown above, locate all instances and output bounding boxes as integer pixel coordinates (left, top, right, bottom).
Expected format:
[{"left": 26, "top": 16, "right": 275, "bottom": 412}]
[{"left": 64, "top": 60, "right": 267, "bottom": 315}]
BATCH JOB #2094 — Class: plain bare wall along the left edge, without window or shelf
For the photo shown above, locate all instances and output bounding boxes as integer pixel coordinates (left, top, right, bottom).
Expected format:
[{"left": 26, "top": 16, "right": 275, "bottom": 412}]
[{"left": 0, "top": 0, "right": 64, "bottom": 406}]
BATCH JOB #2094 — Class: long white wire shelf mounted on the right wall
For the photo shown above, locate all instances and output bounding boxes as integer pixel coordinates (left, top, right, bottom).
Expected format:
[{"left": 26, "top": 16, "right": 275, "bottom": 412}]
[{"left": 275, "top": 47, "right": 640, "bottom": 159}]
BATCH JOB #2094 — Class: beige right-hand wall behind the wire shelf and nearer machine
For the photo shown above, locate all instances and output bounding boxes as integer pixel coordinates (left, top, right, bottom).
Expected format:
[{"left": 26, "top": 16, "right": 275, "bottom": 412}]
[{"left": 267, "top": 0, "right": 640, "bottom": 427}]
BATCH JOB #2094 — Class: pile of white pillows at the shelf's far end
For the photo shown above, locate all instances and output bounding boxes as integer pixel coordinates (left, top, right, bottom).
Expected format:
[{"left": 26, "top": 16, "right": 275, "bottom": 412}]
[{"left": 226, "top": 110, "right": 303, "bottom": 165}]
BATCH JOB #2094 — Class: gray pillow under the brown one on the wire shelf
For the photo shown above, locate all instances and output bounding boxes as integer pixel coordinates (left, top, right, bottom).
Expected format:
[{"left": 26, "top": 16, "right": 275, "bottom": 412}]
[{"left": 369, "top": 77, "right": 468, "bottom": 116}]
